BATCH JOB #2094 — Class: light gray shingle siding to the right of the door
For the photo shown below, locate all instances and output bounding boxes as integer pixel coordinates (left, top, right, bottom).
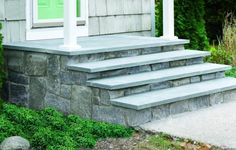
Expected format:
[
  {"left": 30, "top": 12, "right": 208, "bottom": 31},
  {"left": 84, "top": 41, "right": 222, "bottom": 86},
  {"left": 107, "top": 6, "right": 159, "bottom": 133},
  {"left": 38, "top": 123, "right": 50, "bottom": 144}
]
[{"left": 89, "top": 0, "right": 151, "bottom": 36}]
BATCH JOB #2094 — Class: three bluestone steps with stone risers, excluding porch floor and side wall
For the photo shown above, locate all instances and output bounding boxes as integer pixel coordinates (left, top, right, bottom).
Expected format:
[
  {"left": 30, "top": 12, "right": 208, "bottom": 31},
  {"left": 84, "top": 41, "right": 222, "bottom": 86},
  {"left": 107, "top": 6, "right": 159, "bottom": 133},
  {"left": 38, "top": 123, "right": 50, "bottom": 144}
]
[{"left": 67, "top": 36, "right": 236, "bottom": 126}]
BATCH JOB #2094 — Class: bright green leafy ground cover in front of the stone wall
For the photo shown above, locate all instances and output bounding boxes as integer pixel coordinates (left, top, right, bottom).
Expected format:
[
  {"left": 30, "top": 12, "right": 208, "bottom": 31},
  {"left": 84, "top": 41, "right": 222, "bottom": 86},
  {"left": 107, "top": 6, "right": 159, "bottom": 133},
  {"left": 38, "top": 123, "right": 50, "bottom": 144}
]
[{"left": 0, "top": 103, "right": 133, "bottom": 150}]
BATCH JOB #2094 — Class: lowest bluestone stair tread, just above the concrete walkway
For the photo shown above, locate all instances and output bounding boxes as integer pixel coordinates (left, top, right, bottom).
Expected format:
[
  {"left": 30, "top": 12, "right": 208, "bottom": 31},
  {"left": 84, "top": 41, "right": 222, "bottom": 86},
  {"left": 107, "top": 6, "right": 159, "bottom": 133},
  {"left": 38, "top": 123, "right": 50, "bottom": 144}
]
[{"left": 111, "top": 77, "right": 236, "bottom": 110}]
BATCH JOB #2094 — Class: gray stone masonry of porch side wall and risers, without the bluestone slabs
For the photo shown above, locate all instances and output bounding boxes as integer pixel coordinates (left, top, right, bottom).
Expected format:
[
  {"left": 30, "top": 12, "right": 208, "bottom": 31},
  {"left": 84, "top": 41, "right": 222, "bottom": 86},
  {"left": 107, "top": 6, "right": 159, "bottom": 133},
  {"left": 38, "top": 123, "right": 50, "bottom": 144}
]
[{"left": 5, "top": 46, "right": 236, "bottom": 126}]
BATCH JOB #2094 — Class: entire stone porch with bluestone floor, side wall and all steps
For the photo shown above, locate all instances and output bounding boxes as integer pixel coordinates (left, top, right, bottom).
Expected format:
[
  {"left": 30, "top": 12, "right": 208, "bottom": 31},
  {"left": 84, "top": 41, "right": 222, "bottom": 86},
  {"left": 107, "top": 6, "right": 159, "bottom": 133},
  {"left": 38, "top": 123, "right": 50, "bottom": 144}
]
[{"left": 4, "top": 35, "right": 236, "bottom": 126}]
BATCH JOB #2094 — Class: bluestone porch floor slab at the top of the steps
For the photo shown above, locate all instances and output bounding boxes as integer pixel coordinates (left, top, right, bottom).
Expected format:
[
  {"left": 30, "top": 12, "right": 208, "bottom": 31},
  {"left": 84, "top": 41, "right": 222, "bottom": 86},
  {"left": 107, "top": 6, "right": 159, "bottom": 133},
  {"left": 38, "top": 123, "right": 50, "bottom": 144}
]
[{"left": 4, "top": 35, "right": 189, "bottom": 55}]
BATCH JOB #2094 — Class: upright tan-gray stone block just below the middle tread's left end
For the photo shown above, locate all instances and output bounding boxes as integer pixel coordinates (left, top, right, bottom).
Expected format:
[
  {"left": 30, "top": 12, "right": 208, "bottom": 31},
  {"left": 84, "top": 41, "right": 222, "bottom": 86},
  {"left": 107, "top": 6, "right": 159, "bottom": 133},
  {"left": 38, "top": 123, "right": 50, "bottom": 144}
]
[{"left": 71, "top": 85, "right": 93, "bottom": 118}]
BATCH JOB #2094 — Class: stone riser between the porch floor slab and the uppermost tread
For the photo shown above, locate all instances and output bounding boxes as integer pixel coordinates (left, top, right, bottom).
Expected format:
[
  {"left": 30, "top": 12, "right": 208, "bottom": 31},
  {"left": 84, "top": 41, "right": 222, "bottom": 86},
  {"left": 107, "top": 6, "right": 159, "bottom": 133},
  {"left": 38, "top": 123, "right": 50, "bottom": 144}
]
[{"left": 65, "top": 45, "right": 184, "bottom": 63}]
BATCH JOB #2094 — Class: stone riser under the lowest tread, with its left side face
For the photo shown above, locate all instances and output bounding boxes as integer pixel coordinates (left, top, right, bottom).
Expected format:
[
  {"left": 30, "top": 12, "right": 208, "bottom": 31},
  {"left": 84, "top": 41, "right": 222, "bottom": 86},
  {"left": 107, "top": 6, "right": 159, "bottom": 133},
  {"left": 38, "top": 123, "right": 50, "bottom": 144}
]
[{"left": 92, "top": 90, "right": 236, "bottom": 126}]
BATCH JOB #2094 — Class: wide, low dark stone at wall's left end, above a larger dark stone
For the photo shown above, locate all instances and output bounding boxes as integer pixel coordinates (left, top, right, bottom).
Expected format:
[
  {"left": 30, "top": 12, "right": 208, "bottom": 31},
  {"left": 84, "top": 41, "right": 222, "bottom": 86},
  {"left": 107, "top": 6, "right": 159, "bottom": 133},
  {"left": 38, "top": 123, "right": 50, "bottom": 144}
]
[{"left": 8, "top": 71, "right": 29, "bottom": 85}]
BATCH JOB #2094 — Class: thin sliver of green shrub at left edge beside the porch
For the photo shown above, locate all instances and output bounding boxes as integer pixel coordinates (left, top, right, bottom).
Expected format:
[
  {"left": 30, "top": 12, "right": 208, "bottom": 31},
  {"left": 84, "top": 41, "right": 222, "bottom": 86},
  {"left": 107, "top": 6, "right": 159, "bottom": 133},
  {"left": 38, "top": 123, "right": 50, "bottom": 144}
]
[{"left": 0, "top": 23, "right": 5, "bottom": 91}]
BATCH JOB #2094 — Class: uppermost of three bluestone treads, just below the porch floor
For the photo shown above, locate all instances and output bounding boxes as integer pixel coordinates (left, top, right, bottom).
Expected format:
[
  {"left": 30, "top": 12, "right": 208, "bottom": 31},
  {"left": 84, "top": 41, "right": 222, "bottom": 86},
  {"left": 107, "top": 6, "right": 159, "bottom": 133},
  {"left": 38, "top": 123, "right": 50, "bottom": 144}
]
[{"left": 68, "top": 50, "right": 210, "bottom": 73}]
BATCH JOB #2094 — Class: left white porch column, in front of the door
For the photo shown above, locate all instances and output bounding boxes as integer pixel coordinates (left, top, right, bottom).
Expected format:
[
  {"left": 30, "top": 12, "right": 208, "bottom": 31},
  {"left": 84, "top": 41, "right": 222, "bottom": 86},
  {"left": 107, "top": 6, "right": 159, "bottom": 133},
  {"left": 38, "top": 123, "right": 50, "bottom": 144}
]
[{"left": 62, "top": 0, "right": 80, "bottom": 49}]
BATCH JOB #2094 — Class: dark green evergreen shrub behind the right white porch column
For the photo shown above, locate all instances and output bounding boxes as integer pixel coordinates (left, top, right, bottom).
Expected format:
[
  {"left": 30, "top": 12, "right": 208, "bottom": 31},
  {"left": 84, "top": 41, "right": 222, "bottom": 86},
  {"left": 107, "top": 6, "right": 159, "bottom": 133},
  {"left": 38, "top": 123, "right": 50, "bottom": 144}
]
[{"left": 156, "top": 0, "right": 209, "bottom": 50}]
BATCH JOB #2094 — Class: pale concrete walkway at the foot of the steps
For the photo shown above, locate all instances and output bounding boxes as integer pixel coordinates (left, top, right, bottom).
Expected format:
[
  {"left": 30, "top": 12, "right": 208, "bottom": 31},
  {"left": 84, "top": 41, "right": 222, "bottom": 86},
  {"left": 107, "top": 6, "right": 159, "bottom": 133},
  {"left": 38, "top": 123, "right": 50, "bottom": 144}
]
[{"left": 141, "top": 102, "right": 236, "bottom": 149}]
